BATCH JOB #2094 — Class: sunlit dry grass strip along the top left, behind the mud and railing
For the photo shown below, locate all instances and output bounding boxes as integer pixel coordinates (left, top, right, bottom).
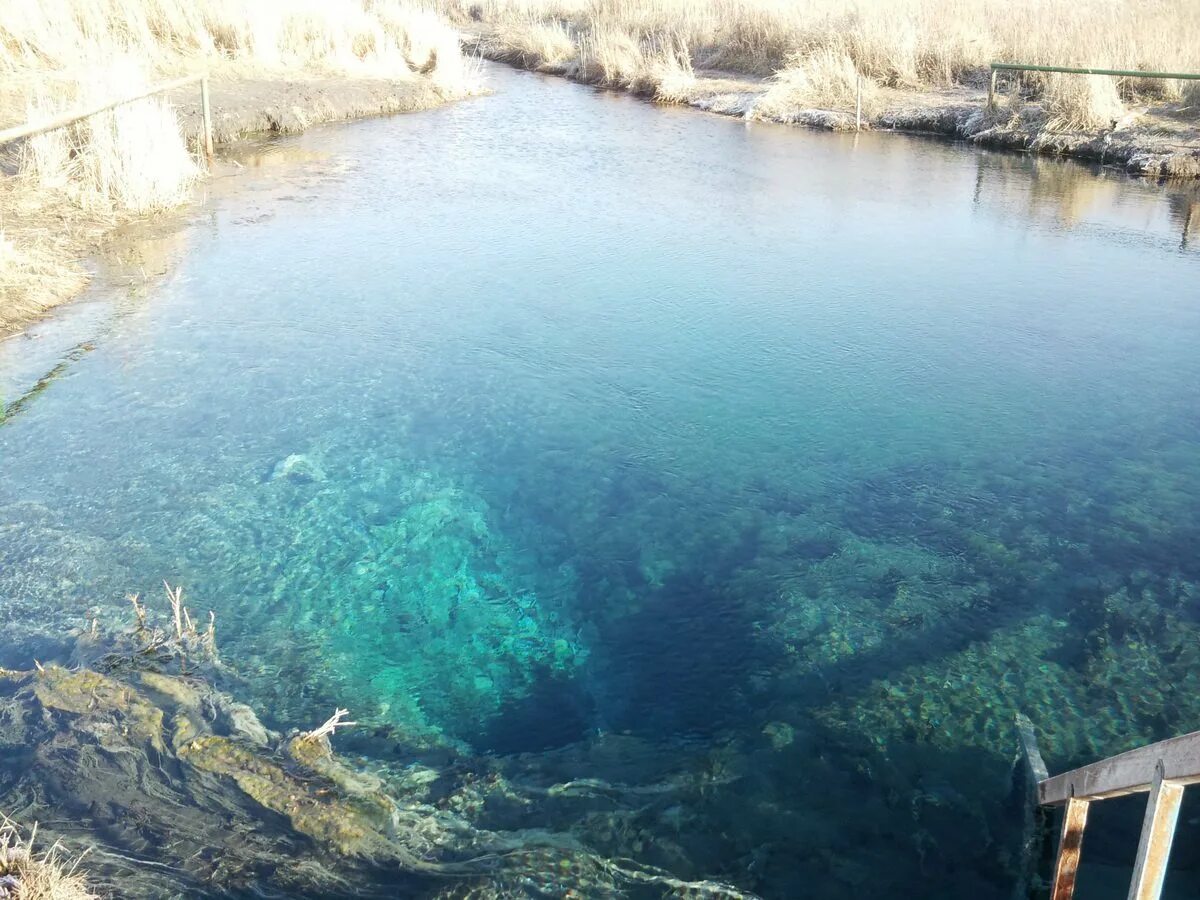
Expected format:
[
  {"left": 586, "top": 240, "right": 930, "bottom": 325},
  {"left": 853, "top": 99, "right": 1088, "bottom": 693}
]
[{"left": 0, "top": 0, "right": 472, "bottom": 89}]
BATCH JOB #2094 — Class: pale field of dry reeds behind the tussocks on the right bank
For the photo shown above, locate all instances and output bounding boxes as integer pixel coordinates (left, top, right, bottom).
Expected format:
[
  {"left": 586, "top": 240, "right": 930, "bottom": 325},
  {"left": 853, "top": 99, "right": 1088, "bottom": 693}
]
[{"left": 445, "top": 0, "right": 1200, "bottom": 83}]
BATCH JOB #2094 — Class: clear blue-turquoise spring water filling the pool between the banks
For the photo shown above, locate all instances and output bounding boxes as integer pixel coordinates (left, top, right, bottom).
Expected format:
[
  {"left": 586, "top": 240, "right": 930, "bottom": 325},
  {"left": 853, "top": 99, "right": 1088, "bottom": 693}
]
[{"left": 0, "top": 61, "right": 1200, "bottom": 899}]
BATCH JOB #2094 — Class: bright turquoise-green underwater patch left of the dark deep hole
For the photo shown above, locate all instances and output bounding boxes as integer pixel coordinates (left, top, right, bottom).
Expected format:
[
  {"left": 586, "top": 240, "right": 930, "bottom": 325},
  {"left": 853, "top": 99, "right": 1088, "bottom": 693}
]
[{"left": 154, "top": 465, "right": 588, "bottom": 743}]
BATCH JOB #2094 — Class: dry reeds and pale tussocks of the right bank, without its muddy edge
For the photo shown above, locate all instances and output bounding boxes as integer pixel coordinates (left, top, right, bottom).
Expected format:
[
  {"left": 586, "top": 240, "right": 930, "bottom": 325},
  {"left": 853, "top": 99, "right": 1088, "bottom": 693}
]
[{"left": 453, "top": 0, "right": 1200, "bottom": 128}]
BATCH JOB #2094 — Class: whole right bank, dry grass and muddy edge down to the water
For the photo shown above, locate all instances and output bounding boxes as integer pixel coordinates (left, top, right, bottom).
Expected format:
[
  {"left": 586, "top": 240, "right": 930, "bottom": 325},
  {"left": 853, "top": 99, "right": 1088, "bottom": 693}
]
[{"left": 449, "top": 0, "right": 1200, "bottom": 178}]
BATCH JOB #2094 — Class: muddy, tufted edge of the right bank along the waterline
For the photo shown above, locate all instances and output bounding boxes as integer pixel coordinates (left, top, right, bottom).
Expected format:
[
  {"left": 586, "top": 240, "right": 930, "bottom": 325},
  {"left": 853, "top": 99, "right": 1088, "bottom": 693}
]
[{"left": 468, "top": 42, "right": 1200, "bottom": 180}]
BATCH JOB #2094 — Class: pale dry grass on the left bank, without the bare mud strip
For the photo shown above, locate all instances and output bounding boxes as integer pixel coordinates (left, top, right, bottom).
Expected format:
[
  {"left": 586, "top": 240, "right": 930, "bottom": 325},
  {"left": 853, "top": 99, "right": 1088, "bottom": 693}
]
[{"left": 0, "top": 0, "right": 480, "bottom": 334}]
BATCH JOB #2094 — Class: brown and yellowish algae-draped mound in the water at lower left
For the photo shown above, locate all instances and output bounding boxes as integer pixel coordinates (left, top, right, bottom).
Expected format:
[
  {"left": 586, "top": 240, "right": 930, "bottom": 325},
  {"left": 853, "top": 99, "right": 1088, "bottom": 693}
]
[{"left": 0, "top": 609, "right": 752, "bottom": 900}]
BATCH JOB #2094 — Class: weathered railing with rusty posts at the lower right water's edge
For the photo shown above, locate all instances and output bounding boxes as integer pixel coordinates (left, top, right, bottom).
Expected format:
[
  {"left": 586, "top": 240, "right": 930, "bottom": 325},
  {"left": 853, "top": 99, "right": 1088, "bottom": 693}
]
[{"left": 1018, "top": 715, "right": 1200, "bottom": 900}]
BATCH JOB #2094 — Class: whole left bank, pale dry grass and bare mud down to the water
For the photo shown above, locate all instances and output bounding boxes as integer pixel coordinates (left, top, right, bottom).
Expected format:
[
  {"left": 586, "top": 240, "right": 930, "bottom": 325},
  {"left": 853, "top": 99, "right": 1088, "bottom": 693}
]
[{"left": 0, "top": 0, "right": 481, "bottom": 336}]
